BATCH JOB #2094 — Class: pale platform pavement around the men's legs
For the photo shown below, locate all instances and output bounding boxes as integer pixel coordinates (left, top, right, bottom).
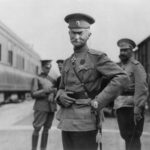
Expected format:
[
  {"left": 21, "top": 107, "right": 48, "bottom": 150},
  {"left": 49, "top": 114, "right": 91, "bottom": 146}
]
[{"left": 0, "top": 101, "right": 150, "bottom": 150}]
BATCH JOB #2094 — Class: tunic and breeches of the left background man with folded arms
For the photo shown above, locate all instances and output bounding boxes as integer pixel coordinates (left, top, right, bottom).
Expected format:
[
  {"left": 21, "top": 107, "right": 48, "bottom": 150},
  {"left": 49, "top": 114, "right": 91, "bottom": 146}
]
[{"left": 31, "top": 73, "right": 56, "bottom": 128}]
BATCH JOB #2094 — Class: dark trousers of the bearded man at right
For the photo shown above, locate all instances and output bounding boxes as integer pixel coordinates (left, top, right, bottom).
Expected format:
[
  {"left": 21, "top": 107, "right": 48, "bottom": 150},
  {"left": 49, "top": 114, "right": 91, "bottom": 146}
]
[{"left": 116, "top": 107, "right": 144, "bottom": 150}]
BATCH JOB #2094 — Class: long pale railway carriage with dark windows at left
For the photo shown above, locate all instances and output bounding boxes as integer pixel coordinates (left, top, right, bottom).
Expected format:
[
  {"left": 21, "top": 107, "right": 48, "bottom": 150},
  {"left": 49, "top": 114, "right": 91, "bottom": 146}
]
[{"left": 0, "top": 19, "right": 41, "bottom": 103}]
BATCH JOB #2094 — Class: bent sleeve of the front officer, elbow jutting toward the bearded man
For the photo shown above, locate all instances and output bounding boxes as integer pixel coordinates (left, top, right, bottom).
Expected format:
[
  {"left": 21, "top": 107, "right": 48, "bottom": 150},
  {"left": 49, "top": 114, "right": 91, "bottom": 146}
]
[{"left": 95, "top": 54, "right": 129, "bottom": 109}]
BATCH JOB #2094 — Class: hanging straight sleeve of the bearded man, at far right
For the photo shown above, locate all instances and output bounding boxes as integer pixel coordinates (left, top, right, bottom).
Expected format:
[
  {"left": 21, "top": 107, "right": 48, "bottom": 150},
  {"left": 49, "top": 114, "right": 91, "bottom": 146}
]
[{"left": 134, "top": 63, "right": 148, "bottom": 113}]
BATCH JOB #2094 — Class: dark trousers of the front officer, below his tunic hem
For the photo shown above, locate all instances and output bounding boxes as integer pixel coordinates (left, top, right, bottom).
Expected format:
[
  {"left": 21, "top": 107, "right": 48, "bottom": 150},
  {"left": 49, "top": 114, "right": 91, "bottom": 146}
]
[{"left": 62, "top": 130, "right": 97, "bottom": 150}]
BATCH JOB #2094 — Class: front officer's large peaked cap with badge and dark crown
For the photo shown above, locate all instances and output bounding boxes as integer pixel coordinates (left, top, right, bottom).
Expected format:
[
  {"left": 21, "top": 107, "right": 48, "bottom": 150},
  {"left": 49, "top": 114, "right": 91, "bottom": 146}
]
[{"left": 64, "top": 13, "right": 95, "bottom": 29}]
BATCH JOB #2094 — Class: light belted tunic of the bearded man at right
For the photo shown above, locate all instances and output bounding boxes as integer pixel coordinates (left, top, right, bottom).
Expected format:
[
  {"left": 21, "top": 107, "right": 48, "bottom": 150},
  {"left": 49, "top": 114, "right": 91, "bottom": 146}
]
[{"left": 114, "top": 58, "right": 148, "bottom": 111}]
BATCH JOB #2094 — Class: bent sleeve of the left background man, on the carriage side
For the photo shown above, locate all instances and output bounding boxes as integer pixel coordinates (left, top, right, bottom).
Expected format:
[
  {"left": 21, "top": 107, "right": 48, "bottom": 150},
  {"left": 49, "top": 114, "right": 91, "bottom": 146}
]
[{"left": 31, "top": 78, "right": 47, "bottom": 98}]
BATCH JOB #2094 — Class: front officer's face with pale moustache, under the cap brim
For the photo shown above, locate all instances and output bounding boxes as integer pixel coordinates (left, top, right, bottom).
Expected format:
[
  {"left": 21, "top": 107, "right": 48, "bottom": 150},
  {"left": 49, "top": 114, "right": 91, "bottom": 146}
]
[{"left": 69, "top": 29, "right": 91, "bottom": 48}]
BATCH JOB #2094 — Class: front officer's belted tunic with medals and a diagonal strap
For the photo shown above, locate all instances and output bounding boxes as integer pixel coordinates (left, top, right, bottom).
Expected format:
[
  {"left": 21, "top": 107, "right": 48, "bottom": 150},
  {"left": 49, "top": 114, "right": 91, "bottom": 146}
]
[{"left": 57, "top": 46, "right": 128, "bottom": 131}]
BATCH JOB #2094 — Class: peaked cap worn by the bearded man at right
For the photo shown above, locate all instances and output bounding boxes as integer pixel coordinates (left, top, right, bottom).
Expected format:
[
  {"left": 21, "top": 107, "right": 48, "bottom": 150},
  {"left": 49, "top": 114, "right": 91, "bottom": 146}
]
[{"left": 117, "top": 38, "right": 136, "bottom": 49}]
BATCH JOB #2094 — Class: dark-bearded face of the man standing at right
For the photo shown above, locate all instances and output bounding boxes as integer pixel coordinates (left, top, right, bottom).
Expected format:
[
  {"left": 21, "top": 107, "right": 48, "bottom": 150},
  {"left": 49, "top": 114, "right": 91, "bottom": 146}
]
[{"left": 119, "top": 48, "right": 132, "bottom": 62}]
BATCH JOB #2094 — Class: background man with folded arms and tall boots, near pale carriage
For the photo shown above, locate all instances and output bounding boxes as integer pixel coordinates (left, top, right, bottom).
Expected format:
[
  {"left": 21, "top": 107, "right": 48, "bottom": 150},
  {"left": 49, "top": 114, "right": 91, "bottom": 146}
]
[{"left": 31, "top": 60, "right": 56, "bottom": 150}]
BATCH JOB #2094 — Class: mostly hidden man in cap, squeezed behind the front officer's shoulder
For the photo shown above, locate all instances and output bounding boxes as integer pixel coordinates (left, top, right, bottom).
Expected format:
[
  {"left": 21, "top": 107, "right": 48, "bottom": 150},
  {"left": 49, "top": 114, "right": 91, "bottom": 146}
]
[{"left": 56, "top": 59, "right": 64, "bottom": 89}]
